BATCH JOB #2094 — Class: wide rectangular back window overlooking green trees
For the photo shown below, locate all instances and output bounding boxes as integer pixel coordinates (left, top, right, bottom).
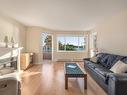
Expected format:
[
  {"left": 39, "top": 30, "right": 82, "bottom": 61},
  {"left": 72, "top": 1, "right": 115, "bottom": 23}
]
[{"left": 57, "top": 36, "right": 87, "bottom": 51}]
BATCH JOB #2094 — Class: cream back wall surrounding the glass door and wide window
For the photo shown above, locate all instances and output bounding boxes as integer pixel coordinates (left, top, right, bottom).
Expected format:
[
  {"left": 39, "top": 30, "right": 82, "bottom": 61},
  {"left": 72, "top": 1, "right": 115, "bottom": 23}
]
[{"left": 27, "top": 27, "right": 88, "bottom": 63}]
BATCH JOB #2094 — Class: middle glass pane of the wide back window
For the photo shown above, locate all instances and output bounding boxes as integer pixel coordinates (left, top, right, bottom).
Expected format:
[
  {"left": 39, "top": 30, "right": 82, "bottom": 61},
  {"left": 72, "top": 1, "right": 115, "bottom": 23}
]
[{"left": 66, "top": 36, "right": 78, "bottom": 51}]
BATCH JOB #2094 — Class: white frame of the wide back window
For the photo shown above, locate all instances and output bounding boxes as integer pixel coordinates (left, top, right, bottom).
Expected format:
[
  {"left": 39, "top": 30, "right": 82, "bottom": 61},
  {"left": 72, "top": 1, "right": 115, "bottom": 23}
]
[{"left": 56, "top": 35, "right": 88, "bottom": 52}]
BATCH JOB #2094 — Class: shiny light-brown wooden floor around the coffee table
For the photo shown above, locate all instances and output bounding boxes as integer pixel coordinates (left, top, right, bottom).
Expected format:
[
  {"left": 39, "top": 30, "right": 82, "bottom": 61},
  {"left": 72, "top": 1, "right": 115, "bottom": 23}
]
[{"left": 21, "top": 62, "right": 107, "bottom": 95}]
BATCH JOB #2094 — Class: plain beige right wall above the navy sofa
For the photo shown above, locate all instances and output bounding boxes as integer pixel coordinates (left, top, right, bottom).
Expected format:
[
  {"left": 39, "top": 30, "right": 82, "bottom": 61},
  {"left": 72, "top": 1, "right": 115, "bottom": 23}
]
[{"left": 93, "top": 10, "right": 127, "bottom": 55}]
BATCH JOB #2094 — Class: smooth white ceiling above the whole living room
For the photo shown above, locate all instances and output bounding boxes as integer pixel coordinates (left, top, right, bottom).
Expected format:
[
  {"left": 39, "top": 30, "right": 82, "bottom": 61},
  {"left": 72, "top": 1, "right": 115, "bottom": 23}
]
[{"left": 0, "top": 0, "right": 127, "bottom": 30}]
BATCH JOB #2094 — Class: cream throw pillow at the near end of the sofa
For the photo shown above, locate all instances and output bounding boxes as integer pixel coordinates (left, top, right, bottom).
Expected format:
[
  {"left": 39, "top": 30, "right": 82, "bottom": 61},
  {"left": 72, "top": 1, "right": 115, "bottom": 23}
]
[{"left": 110, "top": 60, "right": 127, "bottom": 73}]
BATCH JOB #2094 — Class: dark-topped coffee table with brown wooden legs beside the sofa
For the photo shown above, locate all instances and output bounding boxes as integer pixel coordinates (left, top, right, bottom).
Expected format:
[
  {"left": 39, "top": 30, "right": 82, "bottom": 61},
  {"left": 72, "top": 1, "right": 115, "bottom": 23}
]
[{"left": 64, "top": 63, "right": 87, "bottom": 89}]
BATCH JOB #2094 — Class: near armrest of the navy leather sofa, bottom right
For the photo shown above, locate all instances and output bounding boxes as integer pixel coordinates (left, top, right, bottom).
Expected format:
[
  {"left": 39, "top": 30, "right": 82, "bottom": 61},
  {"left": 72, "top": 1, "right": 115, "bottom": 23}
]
[{"left": 108, "top": 73, "right": 127, "bottom": 95}]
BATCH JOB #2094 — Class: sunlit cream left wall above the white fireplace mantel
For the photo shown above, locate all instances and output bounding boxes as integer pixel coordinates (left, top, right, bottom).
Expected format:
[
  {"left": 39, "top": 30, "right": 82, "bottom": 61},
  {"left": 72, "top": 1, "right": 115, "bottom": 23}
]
[{"left": 0, "top": 14, "right": 26, "bottom": 51}]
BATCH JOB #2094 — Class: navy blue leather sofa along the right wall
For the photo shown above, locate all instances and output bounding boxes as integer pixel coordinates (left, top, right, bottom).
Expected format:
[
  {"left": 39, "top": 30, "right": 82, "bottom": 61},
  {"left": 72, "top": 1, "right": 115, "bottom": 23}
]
[{"left": 84, "top": 53, "right": 127, "bottom": 95}]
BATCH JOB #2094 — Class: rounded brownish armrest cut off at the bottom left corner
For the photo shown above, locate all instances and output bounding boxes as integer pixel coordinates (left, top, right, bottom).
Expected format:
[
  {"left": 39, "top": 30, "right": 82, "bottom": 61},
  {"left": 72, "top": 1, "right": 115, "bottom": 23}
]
[{"left": 0, "top": 77, "right": 21, "bottom": 95}]
